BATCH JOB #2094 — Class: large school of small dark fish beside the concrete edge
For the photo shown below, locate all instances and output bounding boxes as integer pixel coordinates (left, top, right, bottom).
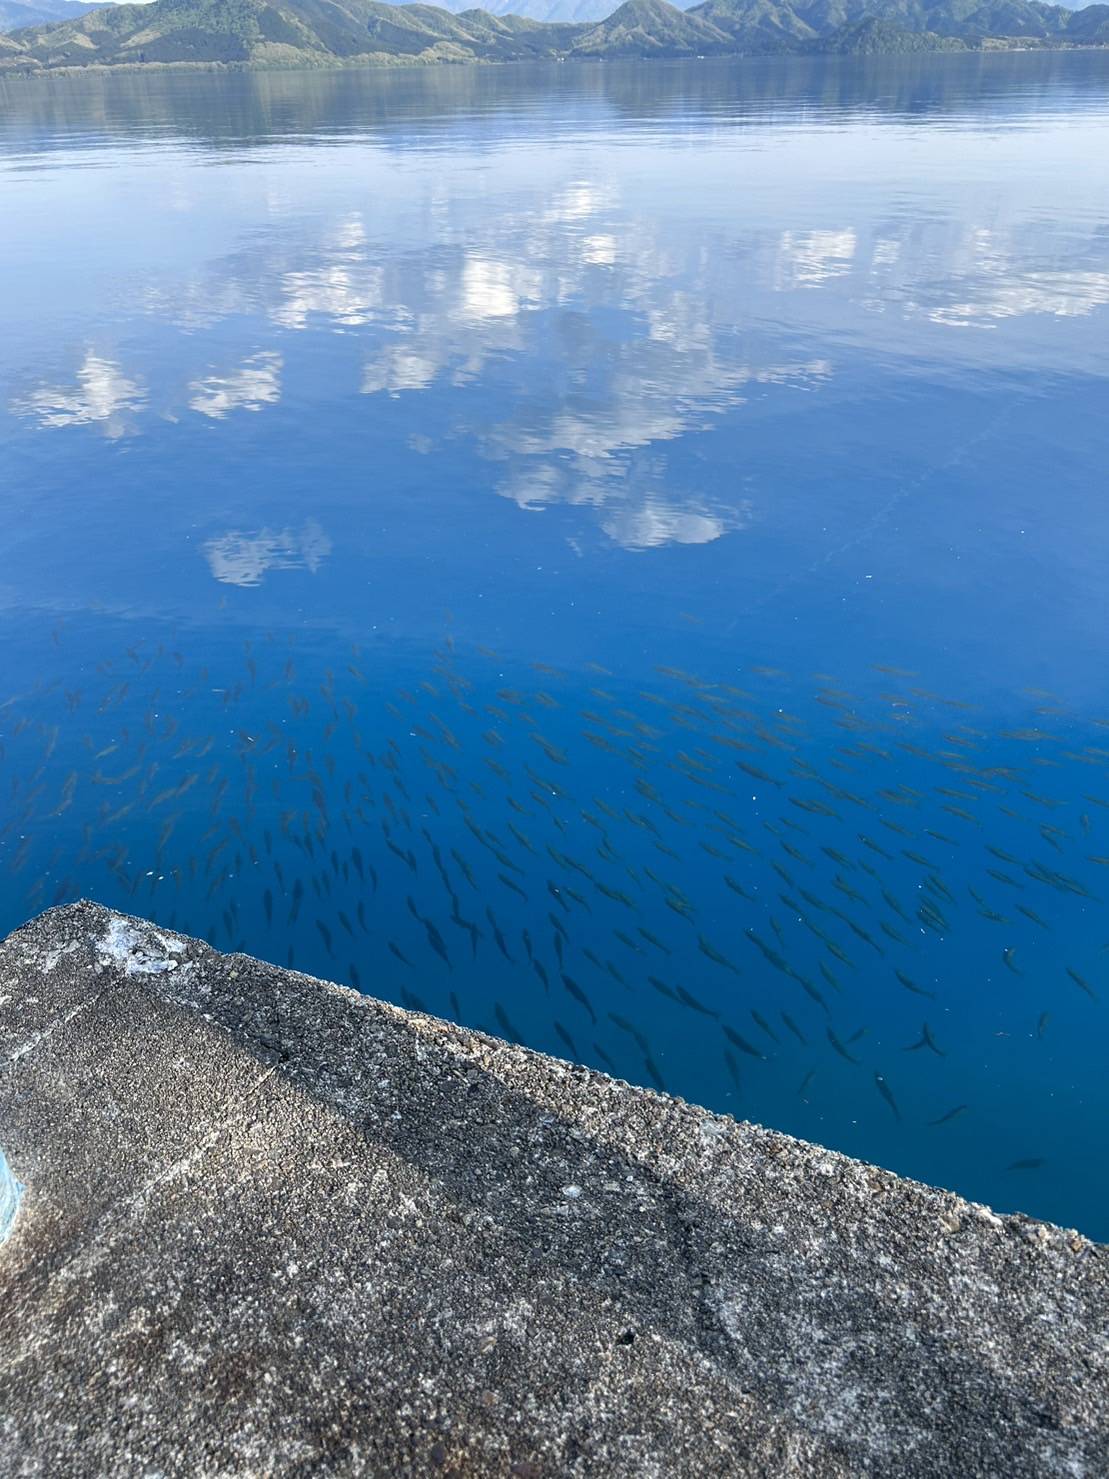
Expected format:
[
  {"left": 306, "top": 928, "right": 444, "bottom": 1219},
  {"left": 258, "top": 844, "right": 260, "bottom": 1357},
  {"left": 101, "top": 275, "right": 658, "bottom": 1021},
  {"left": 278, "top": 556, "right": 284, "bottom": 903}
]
[{"left": 0, "top": 629, "right": 1109, "bottom": 1206}]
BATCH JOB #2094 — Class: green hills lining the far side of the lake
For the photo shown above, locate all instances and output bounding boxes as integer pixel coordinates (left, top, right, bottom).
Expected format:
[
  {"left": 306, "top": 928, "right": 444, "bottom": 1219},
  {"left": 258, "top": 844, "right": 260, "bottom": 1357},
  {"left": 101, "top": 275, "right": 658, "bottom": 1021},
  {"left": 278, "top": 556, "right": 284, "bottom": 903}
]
[{"left": 0, "top": 0, "right": 1109, "bottom": 72}]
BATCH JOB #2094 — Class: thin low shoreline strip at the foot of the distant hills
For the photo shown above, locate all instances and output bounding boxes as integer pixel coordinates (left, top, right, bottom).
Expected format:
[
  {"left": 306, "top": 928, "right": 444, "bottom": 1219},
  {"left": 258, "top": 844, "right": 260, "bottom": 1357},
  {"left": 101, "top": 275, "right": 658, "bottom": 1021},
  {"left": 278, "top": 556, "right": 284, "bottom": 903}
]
[{"left": 0, "top": 37, "right": 1109, "bottom": 83}]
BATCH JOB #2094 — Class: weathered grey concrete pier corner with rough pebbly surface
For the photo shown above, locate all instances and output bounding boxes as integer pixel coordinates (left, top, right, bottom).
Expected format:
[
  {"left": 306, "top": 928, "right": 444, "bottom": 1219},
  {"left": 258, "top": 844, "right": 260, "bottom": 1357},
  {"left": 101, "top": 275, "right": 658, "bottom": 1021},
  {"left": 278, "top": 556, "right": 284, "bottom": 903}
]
[{"left": 0, "top": 904, "right": 1109, "bottom": 1479}]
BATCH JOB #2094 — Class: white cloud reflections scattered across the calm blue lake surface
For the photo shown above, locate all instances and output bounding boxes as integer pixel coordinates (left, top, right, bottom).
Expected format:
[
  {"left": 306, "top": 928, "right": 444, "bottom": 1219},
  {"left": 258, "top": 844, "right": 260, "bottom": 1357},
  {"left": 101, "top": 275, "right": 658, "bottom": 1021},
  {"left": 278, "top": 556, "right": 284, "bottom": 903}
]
[{"left": 12, "top": 109, "right": 1109, "bottom": 556}]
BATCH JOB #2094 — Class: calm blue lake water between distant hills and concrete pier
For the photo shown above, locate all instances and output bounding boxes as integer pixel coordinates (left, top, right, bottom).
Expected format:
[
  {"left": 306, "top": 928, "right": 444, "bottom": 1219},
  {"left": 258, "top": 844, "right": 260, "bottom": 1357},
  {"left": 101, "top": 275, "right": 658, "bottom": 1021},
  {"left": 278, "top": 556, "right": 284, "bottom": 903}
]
[{"left": 0, "top": 53, "right": 1109, "bottom": 1238}]
